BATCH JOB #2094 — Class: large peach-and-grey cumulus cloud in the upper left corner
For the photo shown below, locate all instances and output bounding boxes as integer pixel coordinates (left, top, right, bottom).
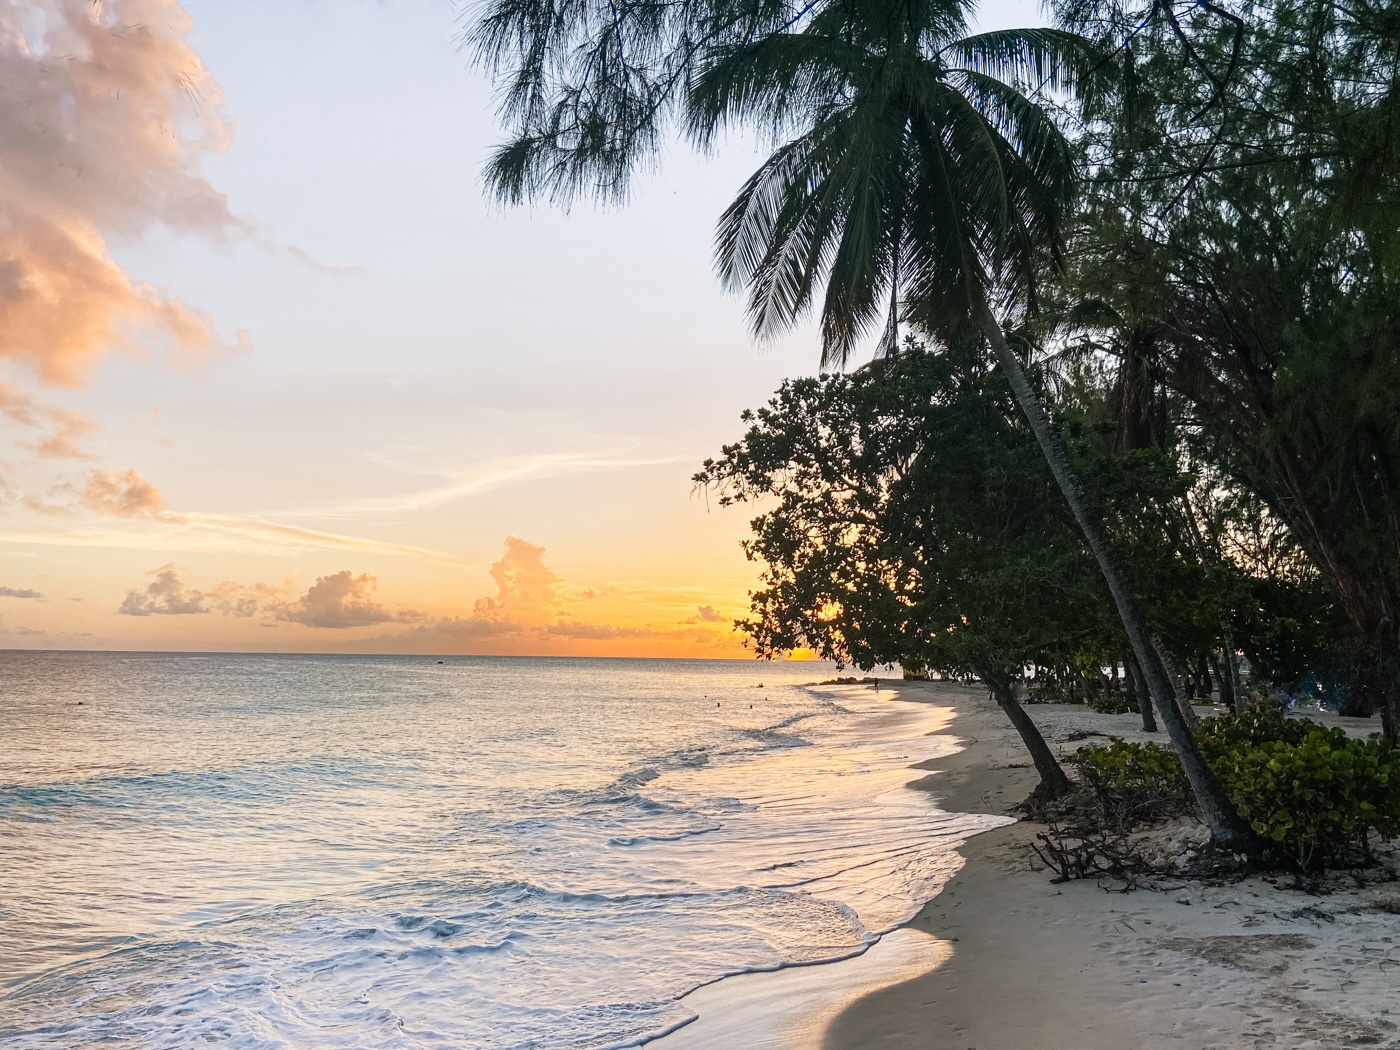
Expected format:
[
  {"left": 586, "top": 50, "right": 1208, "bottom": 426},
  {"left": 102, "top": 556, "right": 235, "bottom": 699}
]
[{"left": 0, "top": 0, "right": 244, "bottom": 385}]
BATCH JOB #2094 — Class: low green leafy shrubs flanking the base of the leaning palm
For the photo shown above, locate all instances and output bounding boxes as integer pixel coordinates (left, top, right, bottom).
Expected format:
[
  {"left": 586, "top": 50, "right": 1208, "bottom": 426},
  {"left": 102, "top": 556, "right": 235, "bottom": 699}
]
[{"left": 1070, "top": 710, "right": 1400, "bottom": 869}]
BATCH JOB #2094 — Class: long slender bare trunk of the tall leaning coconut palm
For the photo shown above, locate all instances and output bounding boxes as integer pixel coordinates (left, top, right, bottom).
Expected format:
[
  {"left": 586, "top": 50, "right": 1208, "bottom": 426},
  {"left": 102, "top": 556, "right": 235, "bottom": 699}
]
[{"left": 979, "top": 302, "right": 1254, "bottom": 851}]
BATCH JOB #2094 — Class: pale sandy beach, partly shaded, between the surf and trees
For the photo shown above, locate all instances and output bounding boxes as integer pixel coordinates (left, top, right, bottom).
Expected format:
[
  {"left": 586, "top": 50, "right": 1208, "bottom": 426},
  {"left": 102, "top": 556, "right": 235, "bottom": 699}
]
[{"left": 655, "top": 683, "right": 1400, "bottom": 1050}]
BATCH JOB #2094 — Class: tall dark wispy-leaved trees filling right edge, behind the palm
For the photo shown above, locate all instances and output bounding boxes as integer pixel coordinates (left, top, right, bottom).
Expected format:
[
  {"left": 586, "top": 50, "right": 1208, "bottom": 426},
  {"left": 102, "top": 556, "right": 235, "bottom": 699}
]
[{"left": 1057, "top": 0, "right": 1400, "bottom": 739}]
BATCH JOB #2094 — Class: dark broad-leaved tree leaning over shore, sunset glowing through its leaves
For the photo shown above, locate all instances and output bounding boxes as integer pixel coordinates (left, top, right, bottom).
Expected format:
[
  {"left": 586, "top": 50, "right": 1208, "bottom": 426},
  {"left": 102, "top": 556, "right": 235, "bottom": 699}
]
[{"left": 696, "top": 340, "right": 1198, "bottom": 797}]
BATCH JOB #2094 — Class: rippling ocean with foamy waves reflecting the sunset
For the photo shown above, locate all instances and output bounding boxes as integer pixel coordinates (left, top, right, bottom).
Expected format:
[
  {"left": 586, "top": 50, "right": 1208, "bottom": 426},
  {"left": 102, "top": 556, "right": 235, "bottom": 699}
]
[{"left": 0, "top": 651, "right": 994, "bottom": 1050}]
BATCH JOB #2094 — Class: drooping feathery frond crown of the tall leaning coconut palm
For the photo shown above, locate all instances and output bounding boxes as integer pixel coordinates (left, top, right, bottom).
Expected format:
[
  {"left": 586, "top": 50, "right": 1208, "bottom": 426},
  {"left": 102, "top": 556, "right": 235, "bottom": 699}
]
[{"left": 687, "top": 0, "right": 1088, "bottom": 365}]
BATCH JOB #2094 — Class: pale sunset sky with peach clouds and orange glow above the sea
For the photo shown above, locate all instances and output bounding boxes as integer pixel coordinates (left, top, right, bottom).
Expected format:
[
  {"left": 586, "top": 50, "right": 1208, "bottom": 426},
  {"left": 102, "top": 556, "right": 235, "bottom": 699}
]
[{"left": 0, "top": 0, "right": 1042, "bottom": 657}]
